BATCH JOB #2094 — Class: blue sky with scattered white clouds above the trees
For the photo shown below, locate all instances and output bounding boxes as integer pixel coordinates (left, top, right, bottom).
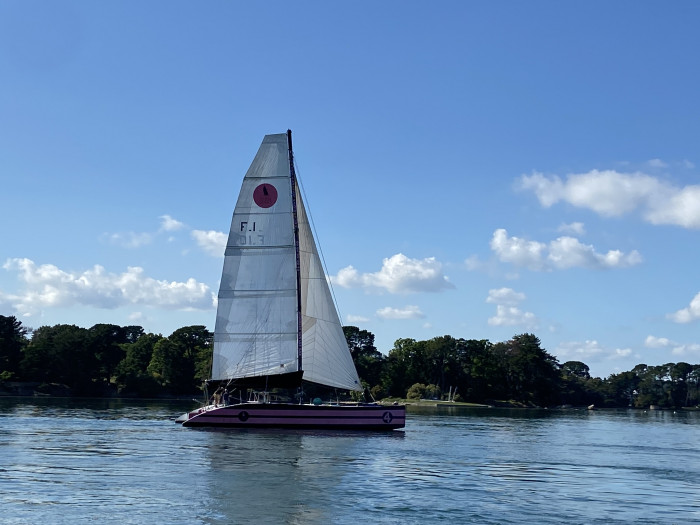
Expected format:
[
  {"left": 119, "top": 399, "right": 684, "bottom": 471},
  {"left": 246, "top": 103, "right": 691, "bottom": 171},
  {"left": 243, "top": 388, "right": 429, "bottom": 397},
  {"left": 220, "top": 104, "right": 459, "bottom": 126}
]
[{"left": 0, "top": 0, "right": 700, "bottom": 377}]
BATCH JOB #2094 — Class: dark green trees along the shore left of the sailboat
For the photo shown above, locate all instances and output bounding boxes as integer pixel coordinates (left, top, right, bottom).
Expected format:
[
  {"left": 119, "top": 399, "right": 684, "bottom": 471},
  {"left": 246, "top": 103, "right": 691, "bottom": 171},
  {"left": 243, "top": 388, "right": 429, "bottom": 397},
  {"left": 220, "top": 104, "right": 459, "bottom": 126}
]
[{"left": 0, "top": 315, "right": 213, "bottom": 397}]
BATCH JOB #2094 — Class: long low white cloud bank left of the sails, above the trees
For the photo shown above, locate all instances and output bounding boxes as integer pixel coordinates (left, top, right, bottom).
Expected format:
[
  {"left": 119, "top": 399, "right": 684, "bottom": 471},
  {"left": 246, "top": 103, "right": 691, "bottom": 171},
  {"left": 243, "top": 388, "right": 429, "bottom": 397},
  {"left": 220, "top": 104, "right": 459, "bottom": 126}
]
[{"left": 3, "top": 259, "right": 214, "bottom": 315}]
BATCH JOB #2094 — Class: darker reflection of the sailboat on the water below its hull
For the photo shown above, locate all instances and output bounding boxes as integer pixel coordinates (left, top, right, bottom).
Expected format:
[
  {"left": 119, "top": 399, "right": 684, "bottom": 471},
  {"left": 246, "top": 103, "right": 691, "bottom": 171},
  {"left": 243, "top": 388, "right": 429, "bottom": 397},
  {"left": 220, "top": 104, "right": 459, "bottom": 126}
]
[{"left": 197, "top": 429, "right": 404, "bottom": 524}]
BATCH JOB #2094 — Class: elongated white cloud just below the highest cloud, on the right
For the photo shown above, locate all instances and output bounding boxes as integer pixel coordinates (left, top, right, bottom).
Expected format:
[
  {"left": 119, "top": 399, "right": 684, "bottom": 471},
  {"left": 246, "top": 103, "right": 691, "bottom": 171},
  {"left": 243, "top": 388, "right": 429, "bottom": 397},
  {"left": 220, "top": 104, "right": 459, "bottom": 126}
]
[{"left": 490, "top": 229, "right": 642, "bottom": 271}]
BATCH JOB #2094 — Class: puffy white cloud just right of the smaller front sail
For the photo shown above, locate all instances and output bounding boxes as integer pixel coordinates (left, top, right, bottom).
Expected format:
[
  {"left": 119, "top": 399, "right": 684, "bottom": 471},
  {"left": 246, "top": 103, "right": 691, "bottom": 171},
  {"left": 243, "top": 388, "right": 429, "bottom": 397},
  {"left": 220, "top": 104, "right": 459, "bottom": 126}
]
[{"left": 331, "top": 253, "right": 454, "bottom": 294}]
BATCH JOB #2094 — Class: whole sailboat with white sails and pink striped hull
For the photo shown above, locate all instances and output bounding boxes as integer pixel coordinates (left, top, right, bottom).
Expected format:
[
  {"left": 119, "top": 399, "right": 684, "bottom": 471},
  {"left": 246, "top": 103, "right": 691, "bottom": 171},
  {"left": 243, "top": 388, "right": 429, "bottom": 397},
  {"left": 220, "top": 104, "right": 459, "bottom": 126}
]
[{"left": 176, "top": 130, "right": 406, "bottom": 430}]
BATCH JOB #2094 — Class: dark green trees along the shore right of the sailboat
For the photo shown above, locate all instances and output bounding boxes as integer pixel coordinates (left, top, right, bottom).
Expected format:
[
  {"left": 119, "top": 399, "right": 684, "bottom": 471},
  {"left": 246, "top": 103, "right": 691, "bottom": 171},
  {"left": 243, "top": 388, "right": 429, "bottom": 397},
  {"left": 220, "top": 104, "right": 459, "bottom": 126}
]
[{"left": 344, "top": 327, "right": 700, "bottom": 408}]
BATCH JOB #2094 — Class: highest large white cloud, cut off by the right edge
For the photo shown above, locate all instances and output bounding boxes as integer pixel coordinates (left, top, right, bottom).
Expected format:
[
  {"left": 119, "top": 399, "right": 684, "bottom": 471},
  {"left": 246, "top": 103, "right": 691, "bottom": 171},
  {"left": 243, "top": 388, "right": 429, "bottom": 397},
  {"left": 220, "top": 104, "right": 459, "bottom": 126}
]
[{"left": 518, "top": 170, "right": 700, "bottom": 225}]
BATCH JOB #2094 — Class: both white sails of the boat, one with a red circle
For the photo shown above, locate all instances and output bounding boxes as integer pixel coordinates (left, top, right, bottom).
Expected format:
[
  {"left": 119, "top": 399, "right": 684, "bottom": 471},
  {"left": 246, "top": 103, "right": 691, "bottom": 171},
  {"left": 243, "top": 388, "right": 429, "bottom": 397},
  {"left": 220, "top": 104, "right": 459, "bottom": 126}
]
[{"left": 212, "top": 133, "right": 361, "bottom": 390}]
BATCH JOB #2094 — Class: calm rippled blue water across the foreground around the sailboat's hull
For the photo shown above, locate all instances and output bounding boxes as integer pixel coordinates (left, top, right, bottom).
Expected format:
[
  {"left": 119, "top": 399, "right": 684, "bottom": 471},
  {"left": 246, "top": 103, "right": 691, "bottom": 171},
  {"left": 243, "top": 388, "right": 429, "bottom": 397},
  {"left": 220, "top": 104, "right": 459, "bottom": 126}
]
[{"left": 0, "top": 399, "right": 700, "bottom": 525}]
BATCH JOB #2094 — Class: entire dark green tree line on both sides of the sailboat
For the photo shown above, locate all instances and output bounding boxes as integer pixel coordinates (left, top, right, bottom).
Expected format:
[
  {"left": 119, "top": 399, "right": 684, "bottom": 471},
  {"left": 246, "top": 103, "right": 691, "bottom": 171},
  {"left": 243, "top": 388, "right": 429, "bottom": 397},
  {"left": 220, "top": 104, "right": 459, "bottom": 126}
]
[{"left": 0, "top": 315, "right": 700, "bottom": 407}]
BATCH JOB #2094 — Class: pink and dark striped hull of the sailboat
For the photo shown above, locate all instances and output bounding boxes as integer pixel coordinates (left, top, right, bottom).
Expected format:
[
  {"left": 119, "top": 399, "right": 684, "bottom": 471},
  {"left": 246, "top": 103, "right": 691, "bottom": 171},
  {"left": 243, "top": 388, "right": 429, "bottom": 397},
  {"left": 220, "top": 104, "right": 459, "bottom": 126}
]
[{"left": 182, "top": 403, "right": 406, "bottom": 430}]
